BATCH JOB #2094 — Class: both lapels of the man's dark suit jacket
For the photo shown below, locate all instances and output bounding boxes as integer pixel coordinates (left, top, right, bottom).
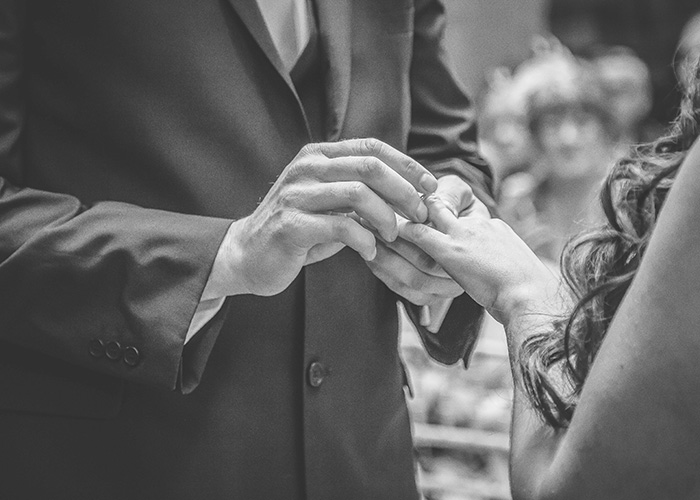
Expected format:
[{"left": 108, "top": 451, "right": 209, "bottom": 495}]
[{"left": 228, "top": 0, "right": 352, "bottom": 140}]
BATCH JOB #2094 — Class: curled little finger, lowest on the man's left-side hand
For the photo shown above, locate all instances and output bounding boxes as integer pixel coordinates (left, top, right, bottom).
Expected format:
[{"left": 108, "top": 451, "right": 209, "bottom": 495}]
[{"left": 290, "top": 214, "right": 377, "bottom": 260}]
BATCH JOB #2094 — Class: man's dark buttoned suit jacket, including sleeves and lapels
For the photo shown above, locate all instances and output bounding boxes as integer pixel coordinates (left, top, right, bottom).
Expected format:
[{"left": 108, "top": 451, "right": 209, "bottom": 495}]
[{"left": 0, "top": 0, "right": 488, "bottom": 500}]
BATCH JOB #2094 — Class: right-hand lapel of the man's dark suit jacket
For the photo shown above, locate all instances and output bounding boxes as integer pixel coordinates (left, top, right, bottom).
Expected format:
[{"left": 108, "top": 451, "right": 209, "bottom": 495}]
[{"left": 315, "top": 0, "right": 352, "bottom": 141}]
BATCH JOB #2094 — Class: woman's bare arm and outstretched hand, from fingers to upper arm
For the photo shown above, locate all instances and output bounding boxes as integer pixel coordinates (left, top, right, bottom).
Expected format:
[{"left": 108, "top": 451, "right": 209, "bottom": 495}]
[{"left": 402, "top": 137, "right": 700, "bottom": 500}]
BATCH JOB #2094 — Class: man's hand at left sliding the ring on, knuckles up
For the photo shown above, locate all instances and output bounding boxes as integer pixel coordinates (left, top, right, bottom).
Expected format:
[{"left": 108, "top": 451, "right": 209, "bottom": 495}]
[{"left": 202, "top": 139, "right": 437, "bottom": 300}]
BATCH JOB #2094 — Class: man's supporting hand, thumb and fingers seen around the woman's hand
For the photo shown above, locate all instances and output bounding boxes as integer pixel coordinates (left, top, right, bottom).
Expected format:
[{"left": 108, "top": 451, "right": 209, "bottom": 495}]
[{"left": 367, "top": 175, "right": 490, "bottom": 308}]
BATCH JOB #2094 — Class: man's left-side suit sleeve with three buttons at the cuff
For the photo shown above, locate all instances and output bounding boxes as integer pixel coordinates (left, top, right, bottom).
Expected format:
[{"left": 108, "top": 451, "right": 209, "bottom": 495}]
[{"left": 0, "top": 1, "right": 231, "bottom": 392}]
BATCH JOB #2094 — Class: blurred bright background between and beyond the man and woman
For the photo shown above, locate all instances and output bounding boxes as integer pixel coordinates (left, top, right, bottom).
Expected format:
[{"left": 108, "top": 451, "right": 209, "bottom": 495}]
[{"left": 402, "top": 0, "right": 700, "bottom": 500}]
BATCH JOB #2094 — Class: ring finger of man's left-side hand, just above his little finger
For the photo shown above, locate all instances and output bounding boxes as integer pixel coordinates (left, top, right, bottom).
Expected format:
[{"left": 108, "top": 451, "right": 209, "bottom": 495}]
[{"left": 292, "top": 181, "right": 398, "bottom": 241}]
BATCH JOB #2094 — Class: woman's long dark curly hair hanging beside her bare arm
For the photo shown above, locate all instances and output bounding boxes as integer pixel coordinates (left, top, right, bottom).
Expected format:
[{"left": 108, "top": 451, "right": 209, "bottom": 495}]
[{"left": 519, "top": 57, "right": 700, "bottom": 428}]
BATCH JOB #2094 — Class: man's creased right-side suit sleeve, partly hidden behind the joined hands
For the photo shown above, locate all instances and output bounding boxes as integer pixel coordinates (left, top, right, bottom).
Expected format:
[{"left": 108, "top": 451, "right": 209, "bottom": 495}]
[{"left": 404, "top": 0, "right": 495, "bottom": 366}]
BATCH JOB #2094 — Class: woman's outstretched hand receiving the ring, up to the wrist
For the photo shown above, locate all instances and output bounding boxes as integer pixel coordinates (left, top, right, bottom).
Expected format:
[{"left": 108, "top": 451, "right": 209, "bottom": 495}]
[{"left": 399, "top": 196, "right": 559, "bottom": 324}]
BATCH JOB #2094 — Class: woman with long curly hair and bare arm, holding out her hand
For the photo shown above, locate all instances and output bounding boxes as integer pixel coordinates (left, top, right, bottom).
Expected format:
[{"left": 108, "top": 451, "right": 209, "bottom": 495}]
[{"left": 400, "top": 54, "right": 700, "bottom": 500}]
